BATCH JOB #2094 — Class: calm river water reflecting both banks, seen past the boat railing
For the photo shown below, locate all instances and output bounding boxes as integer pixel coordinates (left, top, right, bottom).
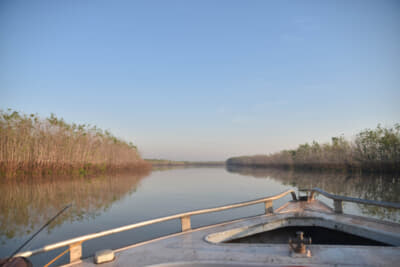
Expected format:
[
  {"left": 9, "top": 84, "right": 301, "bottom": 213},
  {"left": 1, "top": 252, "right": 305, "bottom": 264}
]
[{"left": 0, "top": 167, "right": 400, "bottom": 266}]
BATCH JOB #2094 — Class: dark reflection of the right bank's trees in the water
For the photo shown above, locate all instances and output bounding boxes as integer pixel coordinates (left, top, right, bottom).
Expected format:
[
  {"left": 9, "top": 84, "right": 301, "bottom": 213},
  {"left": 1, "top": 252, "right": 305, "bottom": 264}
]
[{"left": 227, "top": 166, "right": 400, "bottom": 221}]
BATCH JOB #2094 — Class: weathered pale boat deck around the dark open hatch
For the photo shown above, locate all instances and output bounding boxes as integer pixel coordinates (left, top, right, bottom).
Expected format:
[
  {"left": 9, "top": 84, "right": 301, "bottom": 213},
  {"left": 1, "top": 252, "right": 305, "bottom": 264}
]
[{"left": 66, "top": 200, "right": 400, "bottom": 267}]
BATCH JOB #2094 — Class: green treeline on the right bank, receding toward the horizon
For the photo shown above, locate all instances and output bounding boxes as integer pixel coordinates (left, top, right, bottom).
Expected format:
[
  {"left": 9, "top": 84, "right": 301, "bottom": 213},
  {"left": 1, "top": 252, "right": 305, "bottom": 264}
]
[{"left": 227, "top": 124, "right": 400, "bottom": 172}]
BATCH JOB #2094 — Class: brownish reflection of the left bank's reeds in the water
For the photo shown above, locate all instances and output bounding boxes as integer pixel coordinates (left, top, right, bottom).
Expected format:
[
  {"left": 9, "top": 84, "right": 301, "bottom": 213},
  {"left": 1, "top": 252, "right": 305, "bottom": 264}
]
[{"left": 0, "top": 172, "right": 148, "bottom": 242}]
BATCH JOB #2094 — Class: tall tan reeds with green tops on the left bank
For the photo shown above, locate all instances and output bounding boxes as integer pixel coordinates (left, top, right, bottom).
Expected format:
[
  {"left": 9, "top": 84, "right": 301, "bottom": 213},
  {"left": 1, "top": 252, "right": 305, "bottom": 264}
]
[{"left": 0, "top": 109, "right": 150, "bottom": 177}]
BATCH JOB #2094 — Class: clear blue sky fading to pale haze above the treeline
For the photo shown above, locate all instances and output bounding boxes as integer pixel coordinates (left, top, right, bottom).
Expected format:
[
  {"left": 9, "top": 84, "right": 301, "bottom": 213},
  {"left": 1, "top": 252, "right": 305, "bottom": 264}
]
[{"left": 0, "top": 0, "right": 400, "bottom": 160}]
